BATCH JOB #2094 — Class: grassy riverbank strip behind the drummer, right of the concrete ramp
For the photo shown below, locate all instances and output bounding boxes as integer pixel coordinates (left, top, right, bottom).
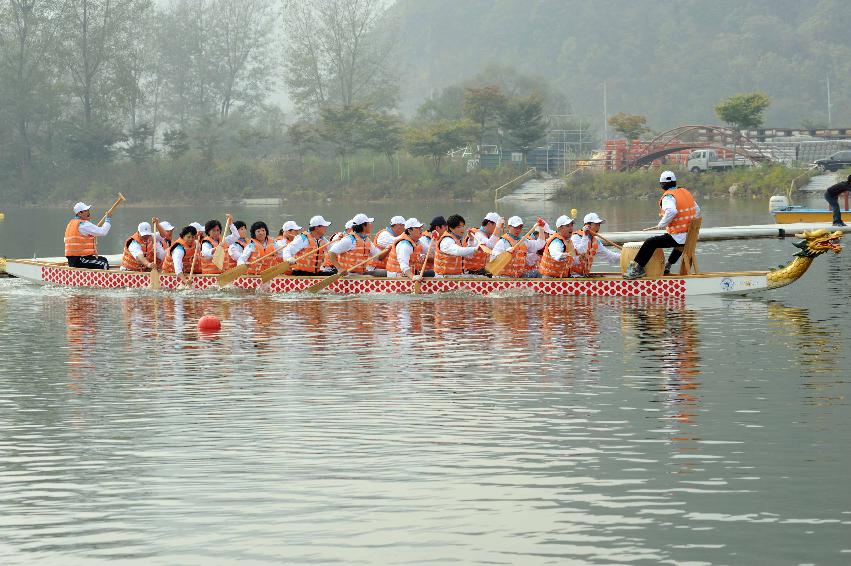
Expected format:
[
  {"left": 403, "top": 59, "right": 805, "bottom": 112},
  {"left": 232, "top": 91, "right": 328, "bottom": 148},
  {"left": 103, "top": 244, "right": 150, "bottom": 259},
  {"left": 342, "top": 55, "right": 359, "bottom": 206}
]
[{"left": 556, "top": 165, "right": 807, "bottom": 201}]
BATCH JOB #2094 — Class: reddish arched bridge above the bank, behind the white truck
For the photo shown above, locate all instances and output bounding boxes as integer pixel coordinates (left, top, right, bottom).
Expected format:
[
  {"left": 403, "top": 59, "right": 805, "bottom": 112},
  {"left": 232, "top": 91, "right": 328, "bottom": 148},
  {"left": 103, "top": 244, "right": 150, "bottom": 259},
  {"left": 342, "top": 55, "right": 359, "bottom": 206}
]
[{"left": 620, "top": 125, "right": 770, "bottom": 171}]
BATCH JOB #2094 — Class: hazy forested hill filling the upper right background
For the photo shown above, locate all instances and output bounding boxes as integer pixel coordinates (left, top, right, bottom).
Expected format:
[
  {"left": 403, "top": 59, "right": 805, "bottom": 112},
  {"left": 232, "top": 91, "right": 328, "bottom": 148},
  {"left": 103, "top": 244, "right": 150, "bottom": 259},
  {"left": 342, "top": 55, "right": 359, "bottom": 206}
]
[{"left": 393, "top": 0, "right": 851, "bottom": 130}]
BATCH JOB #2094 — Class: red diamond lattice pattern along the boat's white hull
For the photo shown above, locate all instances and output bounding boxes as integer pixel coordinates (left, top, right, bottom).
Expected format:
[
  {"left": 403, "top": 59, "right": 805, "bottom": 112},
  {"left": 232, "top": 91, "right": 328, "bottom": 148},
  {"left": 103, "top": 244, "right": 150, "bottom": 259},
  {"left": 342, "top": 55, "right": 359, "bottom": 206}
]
[{"left": 41, "top": 266, "right": 686, "bottom": 297}]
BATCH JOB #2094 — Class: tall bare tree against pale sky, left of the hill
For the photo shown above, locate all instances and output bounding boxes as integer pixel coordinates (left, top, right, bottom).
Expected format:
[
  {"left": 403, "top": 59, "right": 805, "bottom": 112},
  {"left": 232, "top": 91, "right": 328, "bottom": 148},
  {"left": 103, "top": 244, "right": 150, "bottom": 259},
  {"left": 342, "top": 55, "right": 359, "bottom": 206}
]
[{"left": 284, "top": 0, "right": 398, "bottom": 115}]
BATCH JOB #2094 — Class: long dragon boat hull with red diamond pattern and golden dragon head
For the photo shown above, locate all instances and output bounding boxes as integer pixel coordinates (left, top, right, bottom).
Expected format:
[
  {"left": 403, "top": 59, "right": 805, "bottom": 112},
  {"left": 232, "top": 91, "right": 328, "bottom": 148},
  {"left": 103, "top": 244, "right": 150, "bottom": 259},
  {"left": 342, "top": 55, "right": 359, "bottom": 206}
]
[{"left": 6, "top": 229, "right": 842, "bottom": 298}]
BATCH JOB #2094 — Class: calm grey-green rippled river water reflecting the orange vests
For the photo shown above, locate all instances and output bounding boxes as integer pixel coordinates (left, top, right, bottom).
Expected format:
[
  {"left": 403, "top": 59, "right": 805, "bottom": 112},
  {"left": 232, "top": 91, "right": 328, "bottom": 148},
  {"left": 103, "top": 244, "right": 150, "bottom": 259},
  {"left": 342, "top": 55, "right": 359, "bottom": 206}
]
[{"left": 0, "top": 197, "right": 851, "bottom": 565}]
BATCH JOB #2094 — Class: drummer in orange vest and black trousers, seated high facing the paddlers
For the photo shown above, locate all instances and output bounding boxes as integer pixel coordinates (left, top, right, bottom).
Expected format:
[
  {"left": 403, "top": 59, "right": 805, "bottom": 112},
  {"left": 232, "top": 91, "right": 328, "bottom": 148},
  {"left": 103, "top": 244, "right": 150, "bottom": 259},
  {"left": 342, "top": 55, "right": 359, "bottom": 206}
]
[{"left": 623, "top": 171, "right": 700, "bottom": 279}]
